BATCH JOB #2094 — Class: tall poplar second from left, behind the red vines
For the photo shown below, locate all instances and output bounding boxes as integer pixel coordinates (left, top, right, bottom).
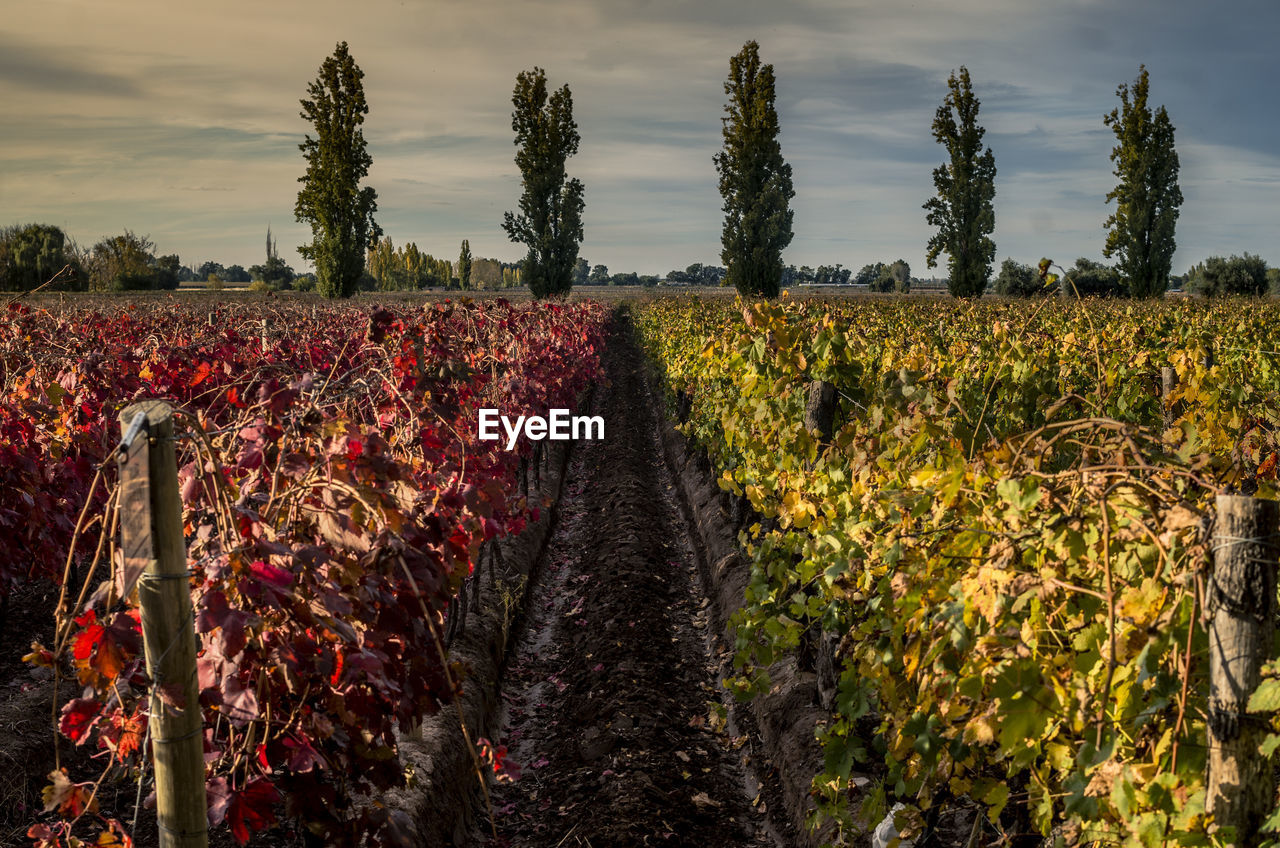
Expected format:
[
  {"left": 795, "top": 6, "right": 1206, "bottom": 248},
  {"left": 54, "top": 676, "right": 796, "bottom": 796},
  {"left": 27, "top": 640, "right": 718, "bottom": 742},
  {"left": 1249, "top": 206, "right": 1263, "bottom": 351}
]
[{"left": 502, "top": 68, "right": 585, "bottom": 297}]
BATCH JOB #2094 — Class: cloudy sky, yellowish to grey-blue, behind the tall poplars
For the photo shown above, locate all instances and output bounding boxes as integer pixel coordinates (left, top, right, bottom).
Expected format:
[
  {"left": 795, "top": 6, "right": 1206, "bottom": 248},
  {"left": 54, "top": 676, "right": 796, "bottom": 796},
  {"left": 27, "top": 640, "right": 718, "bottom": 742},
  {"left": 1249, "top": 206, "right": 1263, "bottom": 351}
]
[{"left": 0, "top": 0, "right": 1280, "bottom": 275}]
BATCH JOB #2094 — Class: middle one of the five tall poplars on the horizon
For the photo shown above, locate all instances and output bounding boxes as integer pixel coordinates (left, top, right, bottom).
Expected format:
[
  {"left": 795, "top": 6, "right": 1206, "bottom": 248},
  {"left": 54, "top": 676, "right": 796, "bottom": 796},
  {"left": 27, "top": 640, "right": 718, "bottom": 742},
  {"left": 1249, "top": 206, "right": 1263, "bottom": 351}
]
[{"left": 714, "top": 41, "right": 795, "bottom": 297}]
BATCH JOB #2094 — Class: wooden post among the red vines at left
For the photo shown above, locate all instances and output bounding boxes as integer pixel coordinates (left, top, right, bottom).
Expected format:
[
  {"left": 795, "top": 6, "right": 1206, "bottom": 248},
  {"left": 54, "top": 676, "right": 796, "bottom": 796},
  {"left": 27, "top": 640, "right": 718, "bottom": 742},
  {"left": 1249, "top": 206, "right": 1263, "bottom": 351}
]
[{"left": 120, "top": 401, "right": 209, "bottom": 848}]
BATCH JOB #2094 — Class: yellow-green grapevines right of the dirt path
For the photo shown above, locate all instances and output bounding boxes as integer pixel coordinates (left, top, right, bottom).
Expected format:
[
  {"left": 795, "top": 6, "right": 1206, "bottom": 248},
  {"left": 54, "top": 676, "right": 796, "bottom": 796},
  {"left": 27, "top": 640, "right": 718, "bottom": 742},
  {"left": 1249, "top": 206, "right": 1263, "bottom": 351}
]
[{"left": 636, "top": 297, "right": 1280, "bottom": 845}]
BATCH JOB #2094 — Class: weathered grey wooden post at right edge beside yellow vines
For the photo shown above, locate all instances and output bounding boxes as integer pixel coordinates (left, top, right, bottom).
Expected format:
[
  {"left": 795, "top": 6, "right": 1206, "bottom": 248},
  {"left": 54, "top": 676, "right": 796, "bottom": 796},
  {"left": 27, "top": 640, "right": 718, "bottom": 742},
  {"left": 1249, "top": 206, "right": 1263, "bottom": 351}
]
[{"left": 1206, "top": 494, "right": 1280, "bottom": 845}]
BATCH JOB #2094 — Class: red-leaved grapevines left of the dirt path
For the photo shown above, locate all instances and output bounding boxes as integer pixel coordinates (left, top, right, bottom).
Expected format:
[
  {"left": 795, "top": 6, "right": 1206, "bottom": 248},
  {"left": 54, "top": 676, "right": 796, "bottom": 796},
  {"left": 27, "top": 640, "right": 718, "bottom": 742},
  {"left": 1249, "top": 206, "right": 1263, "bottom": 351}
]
[{"left": 0, "top": 300, "right": 608, "bottom": 845}]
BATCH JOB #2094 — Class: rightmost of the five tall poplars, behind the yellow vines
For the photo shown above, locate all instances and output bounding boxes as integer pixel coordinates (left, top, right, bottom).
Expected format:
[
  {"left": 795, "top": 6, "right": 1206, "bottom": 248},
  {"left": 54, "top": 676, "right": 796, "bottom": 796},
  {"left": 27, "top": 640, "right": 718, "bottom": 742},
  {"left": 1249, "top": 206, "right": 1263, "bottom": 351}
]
[{"left": 1102, "top": 65, "right": 1183, "bottom": 297}]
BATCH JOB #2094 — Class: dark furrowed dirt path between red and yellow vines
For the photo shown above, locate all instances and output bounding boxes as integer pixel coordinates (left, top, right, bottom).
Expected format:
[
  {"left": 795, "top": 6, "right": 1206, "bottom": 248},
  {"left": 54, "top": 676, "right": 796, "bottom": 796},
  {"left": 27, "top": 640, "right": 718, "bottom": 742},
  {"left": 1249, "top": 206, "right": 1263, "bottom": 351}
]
[{"left": 476, "top": 320, "right": 790, "bottom": 848}]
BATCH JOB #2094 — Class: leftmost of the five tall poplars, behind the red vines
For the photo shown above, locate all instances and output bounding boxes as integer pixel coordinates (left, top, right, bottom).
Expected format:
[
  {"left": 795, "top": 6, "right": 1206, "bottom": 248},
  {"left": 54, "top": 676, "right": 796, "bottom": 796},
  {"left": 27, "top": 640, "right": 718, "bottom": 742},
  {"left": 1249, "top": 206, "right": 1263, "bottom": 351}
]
[{"left": 293, "top": 41, "right": 383, "bottom": 297}]
